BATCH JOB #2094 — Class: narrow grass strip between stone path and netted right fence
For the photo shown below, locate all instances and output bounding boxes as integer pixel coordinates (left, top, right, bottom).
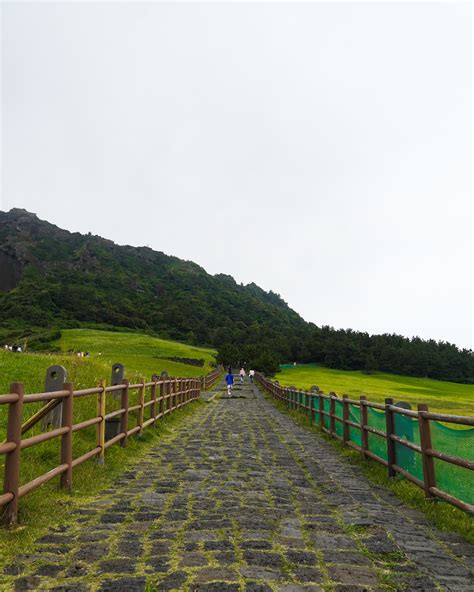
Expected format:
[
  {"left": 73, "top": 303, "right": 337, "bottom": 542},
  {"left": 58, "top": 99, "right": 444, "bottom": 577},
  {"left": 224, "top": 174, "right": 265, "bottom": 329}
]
[{"left": 259, "top": 386, "right": 474, "bottom": 544}]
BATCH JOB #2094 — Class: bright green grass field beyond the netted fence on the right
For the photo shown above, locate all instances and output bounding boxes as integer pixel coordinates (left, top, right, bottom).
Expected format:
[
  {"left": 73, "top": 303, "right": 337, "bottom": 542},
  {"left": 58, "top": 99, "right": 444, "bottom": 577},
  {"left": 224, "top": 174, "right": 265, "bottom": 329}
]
[{"left": 275, "top": 364, "right": 474, "bottom": 415}]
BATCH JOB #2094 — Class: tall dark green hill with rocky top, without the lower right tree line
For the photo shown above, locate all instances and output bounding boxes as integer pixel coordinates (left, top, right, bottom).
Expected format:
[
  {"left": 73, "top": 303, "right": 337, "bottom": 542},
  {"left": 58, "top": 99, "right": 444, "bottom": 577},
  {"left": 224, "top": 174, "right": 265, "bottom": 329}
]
[{"left": 0, "top": 209, "right": 307, "bottom": 367}]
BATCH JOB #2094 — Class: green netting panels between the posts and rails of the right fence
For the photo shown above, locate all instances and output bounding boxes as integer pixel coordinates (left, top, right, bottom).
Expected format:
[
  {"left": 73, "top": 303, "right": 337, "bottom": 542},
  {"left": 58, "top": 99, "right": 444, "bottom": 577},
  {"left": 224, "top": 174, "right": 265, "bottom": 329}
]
[{"left": 295, "top": 392, "right": 474, "bottom": 504}]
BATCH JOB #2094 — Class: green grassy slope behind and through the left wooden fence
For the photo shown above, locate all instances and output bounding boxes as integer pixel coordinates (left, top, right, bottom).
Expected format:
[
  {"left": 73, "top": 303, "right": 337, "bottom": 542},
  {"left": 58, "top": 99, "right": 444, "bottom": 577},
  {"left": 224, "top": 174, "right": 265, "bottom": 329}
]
[{"left": 0, "top": 329, "right": 215, "bottom": 512}]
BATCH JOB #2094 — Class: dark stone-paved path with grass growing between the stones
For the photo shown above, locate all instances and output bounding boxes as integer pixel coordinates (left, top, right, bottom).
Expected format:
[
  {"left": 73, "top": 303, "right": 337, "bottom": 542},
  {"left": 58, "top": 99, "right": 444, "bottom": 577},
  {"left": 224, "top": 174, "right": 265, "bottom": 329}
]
[{"left": 4, "top": 384, "right": 474, "bottom": 592}]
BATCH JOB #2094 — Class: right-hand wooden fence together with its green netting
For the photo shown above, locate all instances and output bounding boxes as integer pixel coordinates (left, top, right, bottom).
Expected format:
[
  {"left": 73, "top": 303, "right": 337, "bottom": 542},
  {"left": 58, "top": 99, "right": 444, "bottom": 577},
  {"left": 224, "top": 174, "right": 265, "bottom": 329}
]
[{"left": 256, "top": 374, "right": 474, "bottom": 514}]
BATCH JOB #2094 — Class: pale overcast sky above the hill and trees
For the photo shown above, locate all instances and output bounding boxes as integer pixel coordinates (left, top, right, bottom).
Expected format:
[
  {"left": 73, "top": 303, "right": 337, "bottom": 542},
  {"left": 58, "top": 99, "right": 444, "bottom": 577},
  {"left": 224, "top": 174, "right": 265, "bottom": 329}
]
[{"left": 1, "top": 2, "right": 473, "bottom": 347}]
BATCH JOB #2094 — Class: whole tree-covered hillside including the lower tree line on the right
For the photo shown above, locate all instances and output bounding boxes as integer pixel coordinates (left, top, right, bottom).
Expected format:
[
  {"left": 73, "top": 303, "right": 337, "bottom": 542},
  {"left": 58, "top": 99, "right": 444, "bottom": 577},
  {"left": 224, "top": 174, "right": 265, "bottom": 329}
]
[{"left": 0, "top": 209, "right": 474, "bottom": 382}]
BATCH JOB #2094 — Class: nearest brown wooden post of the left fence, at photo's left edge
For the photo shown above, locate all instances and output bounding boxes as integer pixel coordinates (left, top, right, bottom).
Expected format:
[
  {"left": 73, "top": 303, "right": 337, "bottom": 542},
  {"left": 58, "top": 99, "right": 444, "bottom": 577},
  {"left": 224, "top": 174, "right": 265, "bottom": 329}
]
[{"left": 3, "top": 382, "right": 25, "bottom": 526}]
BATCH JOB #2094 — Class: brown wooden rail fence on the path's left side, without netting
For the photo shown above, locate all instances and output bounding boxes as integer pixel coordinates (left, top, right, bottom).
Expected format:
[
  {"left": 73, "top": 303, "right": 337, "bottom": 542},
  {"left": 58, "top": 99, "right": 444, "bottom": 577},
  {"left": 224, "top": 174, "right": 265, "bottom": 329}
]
[{"left": 0, "top": 364, "right": 221, "bottom": 526}]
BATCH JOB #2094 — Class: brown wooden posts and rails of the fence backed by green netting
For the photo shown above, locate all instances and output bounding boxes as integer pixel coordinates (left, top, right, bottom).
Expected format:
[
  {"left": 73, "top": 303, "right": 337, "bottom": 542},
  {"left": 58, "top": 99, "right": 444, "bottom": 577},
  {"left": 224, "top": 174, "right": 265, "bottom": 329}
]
[{"left": 256, "top": 374, "right": 474, "bottom": 514}]
